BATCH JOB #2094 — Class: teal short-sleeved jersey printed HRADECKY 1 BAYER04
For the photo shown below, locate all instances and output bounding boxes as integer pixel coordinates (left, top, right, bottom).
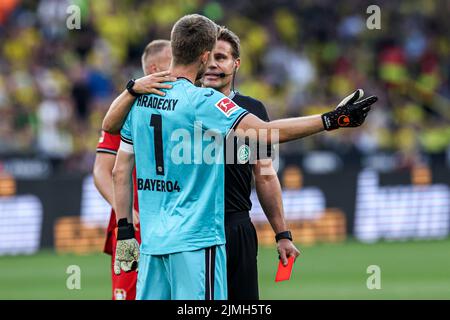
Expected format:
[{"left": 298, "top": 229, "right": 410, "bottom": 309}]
[{"left": 121, "top": 78, "right": 247, "bottom": 255}]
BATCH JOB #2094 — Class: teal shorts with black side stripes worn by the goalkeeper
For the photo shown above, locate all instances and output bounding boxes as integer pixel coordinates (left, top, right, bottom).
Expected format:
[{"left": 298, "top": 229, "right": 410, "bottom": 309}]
[{"left": 136, "top": 245, "right": 228, "bottom": 300}]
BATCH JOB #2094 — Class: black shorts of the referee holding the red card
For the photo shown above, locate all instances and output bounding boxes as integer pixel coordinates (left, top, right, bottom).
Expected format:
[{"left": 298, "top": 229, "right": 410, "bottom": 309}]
[{"left": 225, "top": 212, "right": 259, "bottom": 300}]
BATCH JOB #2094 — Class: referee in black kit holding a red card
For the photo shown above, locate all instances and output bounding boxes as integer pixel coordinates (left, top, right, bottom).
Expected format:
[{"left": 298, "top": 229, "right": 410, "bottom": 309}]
[{"left": 202, "top": 27, "right": 300, "bottom": 300}]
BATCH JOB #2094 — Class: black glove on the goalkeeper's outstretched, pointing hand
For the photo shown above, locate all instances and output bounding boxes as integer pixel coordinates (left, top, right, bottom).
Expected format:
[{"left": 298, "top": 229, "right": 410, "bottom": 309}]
[{"left": 322, "top": 89, "right": 378, "bottom": 130}]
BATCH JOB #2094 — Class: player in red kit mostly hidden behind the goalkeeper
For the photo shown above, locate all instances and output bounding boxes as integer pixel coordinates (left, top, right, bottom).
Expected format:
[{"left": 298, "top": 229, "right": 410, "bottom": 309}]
[{"left": 93, "top": 40, "right": 176, "bottom": 300}]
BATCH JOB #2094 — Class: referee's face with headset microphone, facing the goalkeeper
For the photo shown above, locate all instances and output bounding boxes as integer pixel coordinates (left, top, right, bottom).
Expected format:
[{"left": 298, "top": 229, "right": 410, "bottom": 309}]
[{"left": 202, "top": 40, "right": 239, "bottom": 94}]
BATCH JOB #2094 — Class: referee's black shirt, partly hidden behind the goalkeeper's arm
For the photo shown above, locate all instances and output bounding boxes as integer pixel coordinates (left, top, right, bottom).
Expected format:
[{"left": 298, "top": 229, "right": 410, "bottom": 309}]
[{"left": 225, "top": 93, "right": 270, "bottom": 215}]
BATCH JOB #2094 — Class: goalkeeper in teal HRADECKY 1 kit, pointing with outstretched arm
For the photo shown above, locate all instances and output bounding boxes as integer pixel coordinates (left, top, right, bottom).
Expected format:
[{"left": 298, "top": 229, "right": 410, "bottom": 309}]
[{"left": 111, "top": 15, "right": 377, "bottom": 300}]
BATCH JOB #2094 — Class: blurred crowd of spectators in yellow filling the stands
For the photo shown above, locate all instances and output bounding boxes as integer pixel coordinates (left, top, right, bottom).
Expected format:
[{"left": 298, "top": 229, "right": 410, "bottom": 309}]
[{"left": 0, "top": 0, "right": 450, "bottom": 171}]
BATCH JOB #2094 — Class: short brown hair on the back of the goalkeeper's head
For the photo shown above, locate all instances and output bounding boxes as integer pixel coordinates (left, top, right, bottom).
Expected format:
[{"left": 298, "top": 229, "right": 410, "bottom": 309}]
[{"left": 170, "top": 14, "right": 217, "bottom": 65}]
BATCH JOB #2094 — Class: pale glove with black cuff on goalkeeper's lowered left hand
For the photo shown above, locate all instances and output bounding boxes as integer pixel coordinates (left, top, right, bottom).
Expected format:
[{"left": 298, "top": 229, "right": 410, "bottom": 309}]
[{"left": 114, "top": 219, "right": 139, "bottom": 275}]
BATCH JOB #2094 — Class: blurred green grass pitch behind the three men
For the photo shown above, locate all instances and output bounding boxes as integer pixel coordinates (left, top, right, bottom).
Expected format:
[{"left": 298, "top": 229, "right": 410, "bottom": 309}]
[{"left": 0, "top": 240, "right": 450, "bottom": 299}]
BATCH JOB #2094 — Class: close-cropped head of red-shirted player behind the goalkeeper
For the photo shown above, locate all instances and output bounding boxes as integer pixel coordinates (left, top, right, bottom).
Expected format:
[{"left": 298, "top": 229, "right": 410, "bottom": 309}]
[{"left": 142, "top": 40, "right": 172, "bottom": 75}]
